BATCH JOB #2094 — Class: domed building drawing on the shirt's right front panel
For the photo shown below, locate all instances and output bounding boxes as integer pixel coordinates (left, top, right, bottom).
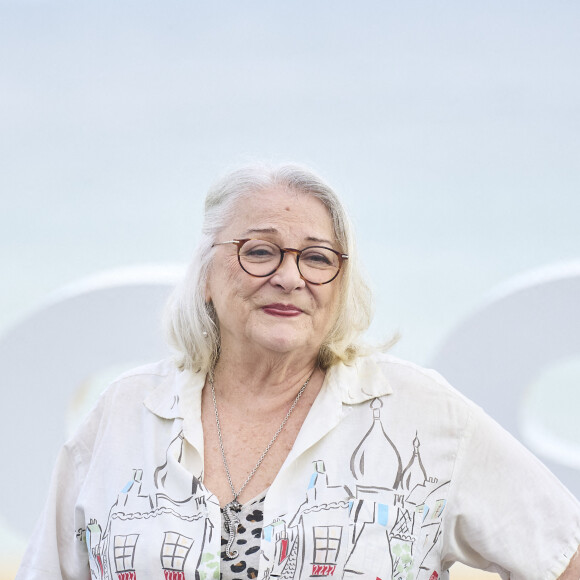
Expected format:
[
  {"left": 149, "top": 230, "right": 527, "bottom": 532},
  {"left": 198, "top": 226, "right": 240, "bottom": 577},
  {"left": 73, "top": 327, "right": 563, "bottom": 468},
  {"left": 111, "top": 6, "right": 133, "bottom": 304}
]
[{"left": 262, "top": 399, "right": 448, "bottom": 580}]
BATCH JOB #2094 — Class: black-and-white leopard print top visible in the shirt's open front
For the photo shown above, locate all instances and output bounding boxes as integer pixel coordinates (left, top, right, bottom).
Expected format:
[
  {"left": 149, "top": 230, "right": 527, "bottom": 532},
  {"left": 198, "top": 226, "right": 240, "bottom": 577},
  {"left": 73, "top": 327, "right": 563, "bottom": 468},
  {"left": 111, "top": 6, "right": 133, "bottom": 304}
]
[{"left": 220, "top": 492, "right": 266, "bottom": 580}]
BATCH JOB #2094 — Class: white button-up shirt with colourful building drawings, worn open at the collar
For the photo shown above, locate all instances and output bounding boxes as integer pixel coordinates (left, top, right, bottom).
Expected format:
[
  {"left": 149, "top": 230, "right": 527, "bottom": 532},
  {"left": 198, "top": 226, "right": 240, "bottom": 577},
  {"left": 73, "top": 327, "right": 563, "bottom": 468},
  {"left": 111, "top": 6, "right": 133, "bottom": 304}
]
[{"left": 17, "top": 355, "right": 580, "bottom": 580}]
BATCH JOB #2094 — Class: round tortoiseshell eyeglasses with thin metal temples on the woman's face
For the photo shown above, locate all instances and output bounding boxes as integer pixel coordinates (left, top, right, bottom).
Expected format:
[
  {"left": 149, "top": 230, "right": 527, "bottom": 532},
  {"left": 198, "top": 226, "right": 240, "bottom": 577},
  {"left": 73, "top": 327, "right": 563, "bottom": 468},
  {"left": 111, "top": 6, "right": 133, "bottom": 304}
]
[{"left": 212, "top": 239, "right": 348, "bottom": 286}]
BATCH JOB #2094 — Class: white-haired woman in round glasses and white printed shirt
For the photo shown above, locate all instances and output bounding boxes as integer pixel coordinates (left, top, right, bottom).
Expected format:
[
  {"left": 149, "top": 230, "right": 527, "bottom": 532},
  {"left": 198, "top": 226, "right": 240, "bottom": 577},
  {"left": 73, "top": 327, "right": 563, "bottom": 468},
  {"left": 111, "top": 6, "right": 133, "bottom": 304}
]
[{"left": 18, "top": 165, "right": 580, "bottom": 580}]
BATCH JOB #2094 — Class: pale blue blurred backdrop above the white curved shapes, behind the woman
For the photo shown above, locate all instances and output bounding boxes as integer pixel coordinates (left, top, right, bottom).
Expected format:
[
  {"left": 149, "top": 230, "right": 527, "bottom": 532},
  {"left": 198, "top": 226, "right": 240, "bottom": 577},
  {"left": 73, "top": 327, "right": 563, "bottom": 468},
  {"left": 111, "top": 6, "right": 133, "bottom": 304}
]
[{"left": 0, "top": 0, "right": 580, "bottom": 568}]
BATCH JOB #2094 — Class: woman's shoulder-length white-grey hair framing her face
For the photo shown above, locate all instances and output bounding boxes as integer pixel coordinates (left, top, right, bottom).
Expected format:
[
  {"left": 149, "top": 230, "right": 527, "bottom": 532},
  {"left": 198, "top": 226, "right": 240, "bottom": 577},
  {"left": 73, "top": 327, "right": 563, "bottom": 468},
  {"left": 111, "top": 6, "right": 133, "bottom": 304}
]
[{"left": 165, "top": 163, "right": 372, "bottom": 373}]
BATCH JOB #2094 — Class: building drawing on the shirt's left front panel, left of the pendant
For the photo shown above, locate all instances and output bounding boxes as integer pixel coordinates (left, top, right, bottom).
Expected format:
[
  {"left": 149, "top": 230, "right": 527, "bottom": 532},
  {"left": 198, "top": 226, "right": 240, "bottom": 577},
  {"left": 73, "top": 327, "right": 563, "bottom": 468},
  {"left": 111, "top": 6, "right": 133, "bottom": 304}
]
[{"left": 80, "top": 434, "right": 219, "bottom": 580}]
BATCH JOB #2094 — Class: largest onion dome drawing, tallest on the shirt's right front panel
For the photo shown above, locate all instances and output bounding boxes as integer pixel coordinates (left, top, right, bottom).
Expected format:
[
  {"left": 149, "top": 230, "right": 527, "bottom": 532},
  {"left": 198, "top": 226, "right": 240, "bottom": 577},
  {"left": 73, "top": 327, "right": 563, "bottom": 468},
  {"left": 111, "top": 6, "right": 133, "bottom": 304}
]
[{"left": 350, "top": 398, "right": 402, "bottom": 489}]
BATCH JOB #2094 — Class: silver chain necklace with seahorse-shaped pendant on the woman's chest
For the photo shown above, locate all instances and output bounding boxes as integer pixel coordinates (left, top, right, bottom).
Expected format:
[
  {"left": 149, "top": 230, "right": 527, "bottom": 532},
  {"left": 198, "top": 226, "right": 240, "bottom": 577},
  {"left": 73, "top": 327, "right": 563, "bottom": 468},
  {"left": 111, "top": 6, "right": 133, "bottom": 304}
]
[{"left": 209, "top": 371, "right": 314, "bottom": 558}]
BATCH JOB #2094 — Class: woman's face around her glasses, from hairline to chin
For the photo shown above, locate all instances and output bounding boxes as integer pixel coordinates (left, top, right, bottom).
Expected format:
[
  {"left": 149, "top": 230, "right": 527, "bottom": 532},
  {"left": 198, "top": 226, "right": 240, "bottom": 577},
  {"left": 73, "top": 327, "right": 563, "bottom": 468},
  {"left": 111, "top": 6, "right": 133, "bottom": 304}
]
[{"left": 206, "top": 188, "right": 341, "bottom": 358}]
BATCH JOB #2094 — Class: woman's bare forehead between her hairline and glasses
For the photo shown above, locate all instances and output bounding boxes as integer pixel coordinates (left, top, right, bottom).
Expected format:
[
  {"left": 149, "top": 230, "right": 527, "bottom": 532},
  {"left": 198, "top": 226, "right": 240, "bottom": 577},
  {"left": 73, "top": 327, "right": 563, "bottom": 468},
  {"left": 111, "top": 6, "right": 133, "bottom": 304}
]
[{"left": 226, "top": 188, "right": 335, "bottom": 243}]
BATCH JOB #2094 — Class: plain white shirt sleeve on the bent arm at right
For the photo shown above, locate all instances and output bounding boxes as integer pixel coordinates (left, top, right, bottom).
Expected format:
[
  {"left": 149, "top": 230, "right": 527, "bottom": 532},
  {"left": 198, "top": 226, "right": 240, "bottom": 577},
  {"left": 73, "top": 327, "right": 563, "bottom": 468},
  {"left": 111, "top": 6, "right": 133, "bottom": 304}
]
[{"left": 443, "top": 406, "right": 580, "bottom": 580}]
